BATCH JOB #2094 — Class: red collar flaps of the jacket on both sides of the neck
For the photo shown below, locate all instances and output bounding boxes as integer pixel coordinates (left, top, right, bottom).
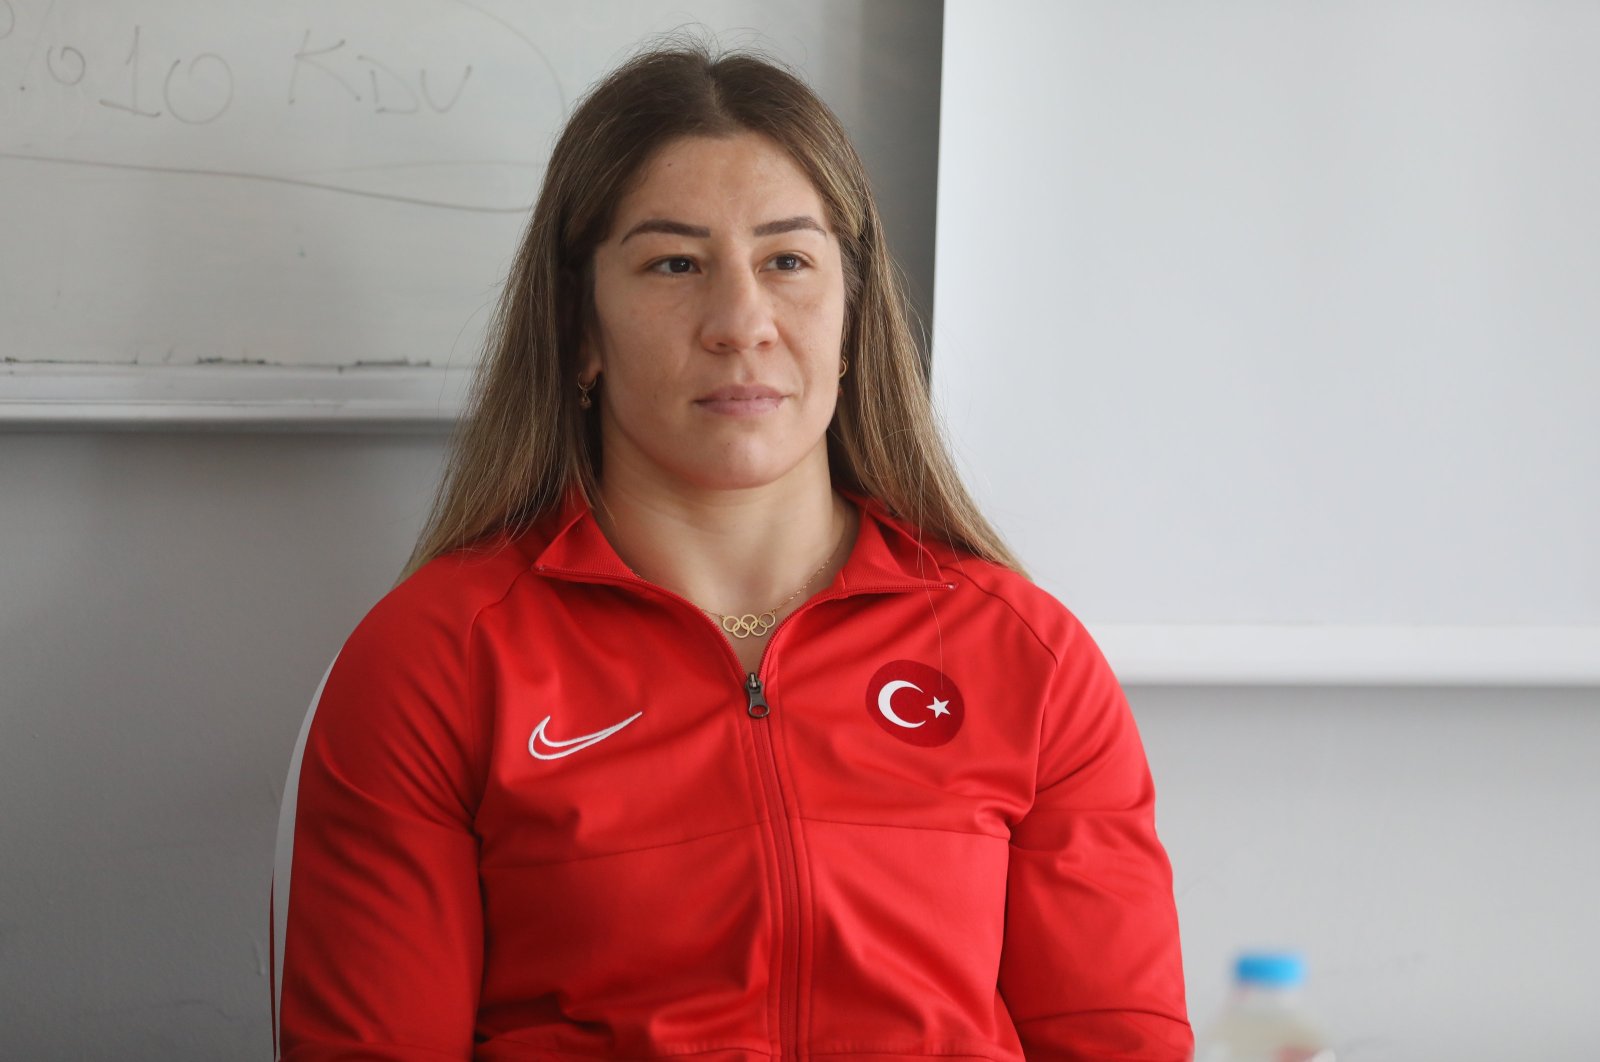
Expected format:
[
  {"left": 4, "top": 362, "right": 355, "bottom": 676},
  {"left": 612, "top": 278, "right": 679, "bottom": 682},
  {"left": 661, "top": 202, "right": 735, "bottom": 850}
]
[{"left": 533, "top": 488, "right": 947, "bottom": 593}]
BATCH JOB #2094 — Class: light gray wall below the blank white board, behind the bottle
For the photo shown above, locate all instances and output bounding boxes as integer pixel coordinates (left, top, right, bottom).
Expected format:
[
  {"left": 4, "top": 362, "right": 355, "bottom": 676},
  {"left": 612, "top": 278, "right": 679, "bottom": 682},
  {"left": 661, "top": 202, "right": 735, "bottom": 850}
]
[{"left": 1128, "top": 686, "right": 1600, "bottom": 1062}]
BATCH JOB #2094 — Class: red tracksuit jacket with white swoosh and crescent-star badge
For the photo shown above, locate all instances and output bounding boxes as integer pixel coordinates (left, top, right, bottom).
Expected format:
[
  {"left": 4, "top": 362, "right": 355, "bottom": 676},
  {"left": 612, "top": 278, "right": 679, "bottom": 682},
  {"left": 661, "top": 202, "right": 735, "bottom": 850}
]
[{"left": 274, "top": 499, "right": 1192, "bottom": 1062}]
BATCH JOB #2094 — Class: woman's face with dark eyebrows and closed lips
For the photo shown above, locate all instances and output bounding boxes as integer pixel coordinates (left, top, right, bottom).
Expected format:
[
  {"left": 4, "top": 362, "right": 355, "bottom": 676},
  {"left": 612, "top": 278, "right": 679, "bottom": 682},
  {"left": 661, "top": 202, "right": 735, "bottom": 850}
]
[{"left": 582, "top": 133, "right": 845, "bottom": 489}]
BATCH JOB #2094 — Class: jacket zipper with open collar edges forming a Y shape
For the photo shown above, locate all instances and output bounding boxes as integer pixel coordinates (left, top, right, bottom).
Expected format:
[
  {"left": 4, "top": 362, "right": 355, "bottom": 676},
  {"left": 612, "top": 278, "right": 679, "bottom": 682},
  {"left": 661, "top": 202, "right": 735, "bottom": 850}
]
[{"left": 538, "top": 565, "right": 955, "bottom": 1059}]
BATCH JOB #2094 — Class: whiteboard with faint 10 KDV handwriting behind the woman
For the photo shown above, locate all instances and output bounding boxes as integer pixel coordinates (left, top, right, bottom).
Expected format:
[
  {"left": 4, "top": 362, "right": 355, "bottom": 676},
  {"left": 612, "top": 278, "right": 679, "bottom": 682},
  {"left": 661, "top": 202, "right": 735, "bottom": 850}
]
[{"left": 0, "top": 0, "right": 938, "bottom": 425}]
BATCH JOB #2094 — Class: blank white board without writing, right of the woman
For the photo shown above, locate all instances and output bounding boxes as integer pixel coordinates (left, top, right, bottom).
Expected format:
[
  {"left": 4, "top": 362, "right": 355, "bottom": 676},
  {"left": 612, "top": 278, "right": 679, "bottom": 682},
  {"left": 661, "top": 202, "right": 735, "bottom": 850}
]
[{"left": 933, "top": 0, "right": 1600, "bottom": 683}]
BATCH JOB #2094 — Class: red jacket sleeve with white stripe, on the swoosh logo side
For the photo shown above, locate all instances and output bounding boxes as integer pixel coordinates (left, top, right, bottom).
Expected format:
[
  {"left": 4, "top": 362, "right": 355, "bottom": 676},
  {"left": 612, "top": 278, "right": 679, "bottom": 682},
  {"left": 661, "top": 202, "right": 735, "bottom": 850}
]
[{"left": 274, "top": 593, "right": 483, "bottom": 1062}]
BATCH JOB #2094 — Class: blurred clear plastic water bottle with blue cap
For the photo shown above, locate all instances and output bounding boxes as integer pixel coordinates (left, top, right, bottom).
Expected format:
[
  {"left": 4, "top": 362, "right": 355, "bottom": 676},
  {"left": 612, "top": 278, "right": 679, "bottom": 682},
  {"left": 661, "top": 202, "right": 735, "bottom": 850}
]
[{"left": 1195, "top": 952, "right": 1334, "bottom": 1062}]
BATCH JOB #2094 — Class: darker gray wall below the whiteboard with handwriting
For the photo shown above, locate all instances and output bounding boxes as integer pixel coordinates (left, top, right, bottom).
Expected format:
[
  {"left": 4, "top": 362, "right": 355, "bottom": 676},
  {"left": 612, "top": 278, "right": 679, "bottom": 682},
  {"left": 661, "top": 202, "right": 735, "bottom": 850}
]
[{"left": 0, "top": 433, "right": 440, "bottom": 1060}]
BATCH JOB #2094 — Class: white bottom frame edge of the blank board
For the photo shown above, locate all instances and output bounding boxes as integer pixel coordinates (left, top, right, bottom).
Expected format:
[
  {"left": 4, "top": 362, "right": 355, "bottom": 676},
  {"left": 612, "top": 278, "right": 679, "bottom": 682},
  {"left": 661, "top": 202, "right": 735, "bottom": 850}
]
[{"left": 1086, "top": 624, "right": 1600, "bottom": 688}]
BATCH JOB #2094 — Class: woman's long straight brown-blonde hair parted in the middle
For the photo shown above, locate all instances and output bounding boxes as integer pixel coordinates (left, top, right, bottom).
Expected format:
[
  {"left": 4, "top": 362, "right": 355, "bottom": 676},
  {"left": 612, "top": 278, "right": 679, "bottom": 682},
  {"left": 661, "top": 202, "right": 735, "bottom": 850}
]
[{"left": 400, "top": 40, "right": 1022, "bottom": 581}]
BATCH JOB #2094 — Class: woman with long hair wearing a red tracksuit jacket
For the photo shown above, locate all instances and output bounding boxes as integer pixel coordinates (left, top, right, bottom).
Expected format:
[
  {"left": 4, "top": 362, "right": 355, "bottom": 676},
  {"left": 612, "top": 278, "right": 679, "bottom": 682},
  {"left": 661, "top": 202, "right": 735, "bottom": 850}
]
[{"left": 275, "top": 41, "right": 1190, "bottom": 1062}]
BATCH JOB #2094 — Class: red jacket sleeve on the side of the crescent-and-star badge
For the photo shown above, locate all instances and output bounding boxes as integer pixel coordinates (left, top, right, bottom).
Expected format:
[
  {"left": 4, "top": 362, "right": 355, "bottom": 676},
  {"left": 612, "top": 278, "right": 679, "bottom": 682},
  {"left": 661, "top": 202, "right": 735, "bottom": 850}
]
[{"left": 1000, "top": 616, "right": 1194, "bottom": 1062}]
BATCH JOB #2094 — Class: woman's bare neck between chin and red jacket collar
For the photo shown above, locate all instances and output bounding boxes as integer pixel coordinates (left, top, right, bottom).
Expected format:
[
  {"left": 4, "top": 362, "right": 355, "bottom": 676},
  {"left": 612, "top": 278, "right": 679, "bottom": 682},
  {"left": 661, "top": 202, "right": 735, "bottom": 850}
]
[{"left": 595, "top": 464, "right": 854, "bottom": 614}]
